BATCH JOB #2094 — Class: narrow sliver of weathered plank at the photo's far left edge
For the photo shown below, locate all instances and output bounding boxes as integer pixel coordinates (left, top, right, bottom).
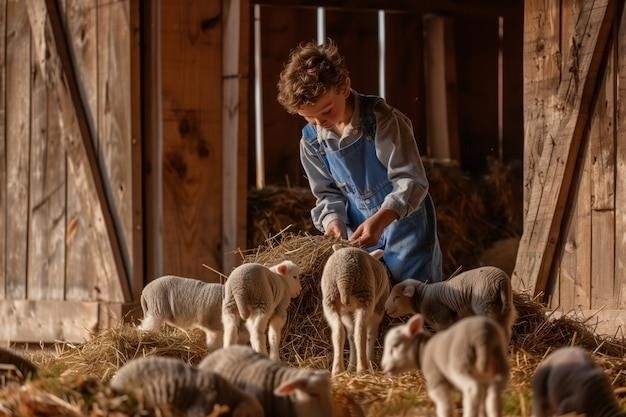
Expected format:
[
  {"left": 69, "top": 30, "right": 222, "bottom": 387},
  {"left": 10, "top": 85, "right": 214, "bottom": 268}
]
[{"left": 0, "top": 0, "right": 8, "bottom": 300}]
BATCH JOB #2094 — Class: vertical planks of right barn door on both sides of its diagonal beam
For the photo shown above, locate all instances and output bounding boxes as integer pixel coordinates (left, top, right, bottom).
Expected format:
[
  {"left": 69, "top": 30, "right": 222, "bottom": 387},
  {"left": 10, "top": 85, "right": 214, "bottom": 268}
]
[{"left": 516, "top": 0, "right": 626, "bottom": 333}]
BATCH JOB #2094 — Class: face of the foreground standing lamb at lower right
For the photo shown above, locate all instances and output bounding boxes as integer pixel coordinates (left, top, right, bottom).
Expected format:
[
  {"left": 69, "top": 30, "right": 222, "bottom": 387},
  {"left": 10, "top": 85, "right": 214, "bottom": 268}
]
[{"left": 381, "top": 323, "right": 418, "bottom": 375}]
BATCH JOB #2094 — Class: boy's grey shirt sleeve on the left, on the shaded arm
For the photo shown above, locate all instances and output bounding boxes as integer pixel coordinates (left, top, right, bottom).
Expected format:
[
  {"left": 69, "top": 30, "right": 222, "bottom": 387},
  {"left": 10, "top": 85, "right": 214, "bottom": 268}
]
[{"left": 300, "top": 139, "right": 347, "bottom": 232}]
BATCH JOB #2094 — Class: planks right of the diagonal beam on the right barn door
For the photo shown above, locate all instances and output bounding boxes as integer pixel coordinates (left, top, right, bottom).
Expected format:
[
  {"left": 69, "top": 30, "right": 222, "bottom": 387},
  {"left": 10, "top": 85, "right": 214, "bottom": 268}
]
[{"left": 550, "top": 2, "right": 626, "bottom": 320}]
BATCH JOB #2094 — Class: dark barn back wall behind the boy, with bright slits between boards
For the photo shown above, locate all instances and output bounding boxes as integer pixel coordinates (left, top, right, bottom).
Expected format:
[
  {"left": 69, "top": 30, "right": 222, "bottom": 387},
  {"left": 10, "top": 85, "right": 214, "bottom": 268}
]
[{"left": 248, "top": 2, "right": 523, "bottom": 186}]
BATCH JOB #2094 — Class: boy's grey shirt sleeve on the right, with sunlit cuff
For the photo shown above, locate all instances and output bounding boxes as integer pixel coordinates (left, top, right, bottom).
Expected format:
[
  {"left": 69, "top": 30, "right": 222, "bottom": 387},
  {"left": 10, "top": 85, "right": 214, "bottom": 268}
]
[{"left": 375, "top": 103, "right": 428, "bottom": 218}]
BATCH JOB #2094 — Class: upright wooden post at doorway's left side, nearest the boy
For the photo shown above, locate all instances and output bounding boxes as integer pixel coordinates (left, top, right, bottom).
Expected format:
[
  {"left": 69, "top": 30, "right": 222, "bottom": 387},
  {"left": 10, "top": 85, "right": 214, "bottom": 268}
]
[{"left": 221, "top": 1, "right": 250, "bottom": 272}]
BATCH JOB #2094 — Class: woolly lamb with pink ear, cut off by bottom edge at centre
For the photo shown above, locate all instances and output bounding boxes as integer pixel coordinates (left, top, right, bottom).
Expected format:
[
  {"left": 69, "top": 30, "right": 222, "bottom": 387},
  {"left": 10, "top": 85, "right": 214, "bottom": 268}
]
[{"left": 198, "top": 345, "right": 333, "bottom": 417}]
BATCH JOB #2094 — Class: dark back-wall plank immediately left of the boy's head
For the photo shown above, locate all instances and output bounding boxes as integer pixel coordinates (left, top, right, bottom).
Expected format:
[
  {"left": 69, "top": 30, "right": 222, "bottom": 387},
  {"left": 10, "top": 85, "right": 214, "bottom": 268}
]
[{"left": 260, "top": 7, "right": 316, "bottom": 187}]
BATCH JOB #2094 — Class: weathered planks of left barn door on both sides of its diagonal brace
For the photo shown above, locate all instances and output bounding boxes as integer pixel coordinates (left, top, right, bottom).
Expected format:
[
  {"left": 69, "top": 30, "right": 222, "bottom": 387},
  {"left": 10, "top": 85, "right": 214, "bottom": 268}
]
[{"left": 0, "top": 0, "right": 140, "bottom": 340}]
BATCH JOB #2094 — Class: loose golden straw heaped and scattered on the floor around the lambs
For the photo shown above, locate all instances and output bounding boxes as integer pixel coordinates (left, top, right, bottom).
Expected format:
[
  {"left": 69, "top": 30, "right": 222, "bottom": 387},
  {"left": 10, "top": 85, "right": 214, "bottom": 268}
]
[{"left": 0, "top": 235, "right": 626, "bottom": 417}]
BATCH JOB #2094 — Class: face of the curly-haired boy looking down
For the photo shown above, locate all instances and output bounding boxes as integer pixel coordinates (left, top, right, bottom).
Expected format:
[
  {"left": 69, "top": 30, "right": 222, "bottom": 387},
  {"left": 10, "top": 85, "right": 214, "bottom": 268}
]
[{"left": 298, "top": 79, "right": 350, "bottom": 129}]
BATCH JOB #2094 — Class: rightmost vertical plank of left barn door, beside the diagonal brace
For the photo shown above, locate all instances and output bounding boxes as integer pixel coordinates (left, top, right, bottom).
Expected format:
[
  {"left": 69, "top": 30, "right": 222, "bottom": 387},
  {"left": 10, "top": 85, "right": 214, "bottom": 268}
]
[{"left": 96, "top": 0, "right": 135, "bottom": 300}]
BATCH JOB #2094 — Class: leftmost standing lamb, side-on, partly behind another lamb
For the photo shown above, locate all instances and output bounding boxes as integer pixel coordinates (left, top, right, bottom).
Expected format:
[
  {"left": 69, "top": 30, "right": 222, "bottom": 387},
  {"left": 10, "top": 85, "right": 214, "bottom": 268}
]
[{"left": 139, "top": 275, "right": 247, "bottom": 350}]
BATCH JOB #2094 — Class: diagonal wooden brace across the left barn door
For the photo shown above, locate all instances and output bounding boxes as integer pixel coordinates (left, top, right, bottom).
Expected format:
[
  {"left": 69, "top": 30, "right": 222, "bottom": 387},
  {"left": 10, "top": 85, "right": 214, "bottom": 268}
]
[{"left": 25, "top": 0, "right": 132, "bottom": 301}]
